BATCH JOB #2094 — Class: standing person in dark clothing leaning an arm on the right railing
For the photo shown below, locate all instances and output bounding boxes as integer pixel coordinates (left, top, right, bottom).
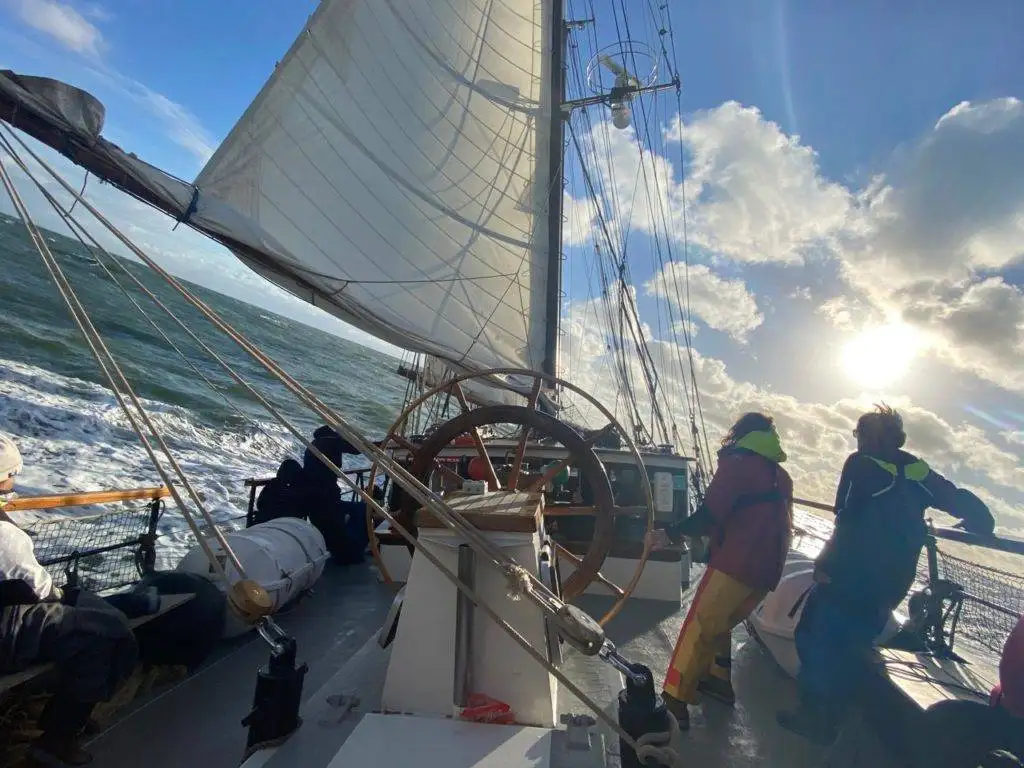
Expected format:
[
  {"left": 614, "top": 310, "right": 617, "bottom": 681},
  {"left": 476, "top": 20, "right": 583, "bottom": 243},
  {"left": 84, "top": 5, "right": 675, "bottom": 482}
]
[{"left": 778, "top": 404, "right": 994, "bottom": 744}]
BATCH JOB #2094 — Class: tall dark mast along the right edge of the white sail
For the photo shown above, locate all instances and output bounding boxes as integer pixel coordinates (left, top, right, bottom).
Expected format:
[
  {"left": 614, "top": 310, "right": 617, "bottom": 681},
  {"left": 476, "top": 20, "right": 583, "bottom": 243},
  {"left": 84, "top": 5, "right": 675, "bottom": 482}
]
[{"left": 541, "top": 0, "right": 568, "bottom": 376}]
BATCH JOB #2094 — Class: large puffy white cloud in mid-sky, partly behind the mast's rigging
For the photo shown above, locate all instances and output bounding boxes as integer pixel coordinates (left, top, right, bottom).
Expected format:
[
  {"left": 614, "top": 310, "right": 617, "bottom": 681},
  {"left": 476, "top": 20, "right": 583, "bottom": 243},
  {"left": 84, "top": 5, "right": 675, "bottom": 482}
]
[{"left": 581, "top": 101, "right": 851, "bottom": 264}]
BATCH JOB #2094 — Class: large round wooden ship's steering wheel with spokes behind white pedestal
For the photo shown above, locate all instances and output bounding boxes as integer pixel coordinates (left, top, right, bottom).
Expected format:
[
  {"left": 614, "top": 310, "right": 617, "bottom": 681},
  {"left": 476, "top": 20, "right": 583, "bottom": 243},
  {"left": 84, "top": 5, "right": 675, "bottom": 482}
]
[{"left": 367, "top": 369, "right": 654, "bottom": 625}]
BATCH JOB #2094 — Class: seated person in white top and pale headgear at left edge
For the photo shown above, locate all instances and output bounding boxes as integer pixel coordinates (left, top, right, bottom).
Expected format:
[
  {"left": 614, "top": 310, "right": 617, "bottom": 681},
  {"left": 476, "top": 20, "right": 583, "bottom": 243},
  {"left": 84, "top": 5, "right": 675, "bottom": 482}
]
[{"left": 0, "top": 434, "right": 138, "bottom": 765}]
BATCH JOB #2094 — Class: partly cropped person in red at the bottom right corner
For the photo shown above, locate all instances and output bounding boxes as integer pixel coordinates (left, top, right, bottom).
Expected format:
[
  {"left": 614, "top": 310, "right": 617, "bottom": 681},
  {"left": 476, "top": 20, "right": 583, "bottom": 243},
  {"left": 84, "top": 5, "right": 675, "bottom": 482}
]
[{"left": 918, "top": 617, "right": 1024, "bottom": 768}]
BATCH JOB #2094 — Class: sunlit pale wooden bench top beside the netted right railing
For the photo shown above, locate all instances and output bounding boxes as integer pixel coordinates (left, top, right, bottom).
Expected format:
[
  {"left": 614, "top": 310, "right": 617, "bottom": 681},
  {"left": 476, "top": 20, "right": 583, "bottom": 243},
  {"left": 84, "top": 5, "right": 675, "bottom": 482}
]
[{"left": 877, "top": 648, "right": 999, "bottom": 711}]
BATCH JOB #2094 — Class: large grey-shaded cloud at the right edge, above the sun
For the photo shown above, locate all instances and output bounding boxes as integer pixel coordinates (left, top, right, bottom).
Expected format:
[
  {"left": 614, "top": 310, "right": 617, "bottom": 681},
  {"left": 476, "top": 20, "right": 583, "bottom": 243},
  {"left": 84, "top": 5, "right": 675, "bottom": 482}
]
[{"left": 841, "top": 98, "right": 1024, "bottom": 391}]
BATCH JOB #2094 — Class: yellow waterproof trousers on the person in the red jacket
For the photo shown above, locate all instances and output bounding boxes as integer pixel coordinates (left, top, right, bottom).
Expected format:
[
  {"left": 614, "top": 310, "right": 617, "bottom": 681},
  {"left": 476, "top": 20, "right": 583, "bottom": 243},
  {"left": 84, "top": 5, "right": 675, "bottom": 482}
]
[{"left": 664, "top": 567, "right": 766, "bottom": 703}]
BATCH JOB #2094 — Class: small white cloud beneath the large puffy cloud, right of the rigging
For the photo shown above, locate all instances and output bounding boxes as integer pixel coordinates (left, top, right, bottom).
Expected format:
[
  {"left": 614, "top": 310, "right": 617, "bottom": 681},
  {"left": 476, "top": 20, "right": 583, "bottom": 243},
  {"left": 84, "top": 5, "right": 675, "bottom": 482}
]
[{"left": 644, "top": 261, "right": 765, "bottom": 342}]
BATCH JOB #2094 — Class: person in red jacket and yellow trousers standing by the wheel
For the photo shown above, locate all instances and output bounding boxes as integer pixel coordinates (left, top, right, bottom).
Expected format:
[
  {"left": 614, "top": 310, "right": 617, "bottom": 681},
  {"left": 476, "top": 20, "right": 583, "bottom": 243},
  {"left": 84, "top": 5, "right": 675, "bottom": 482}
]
[{"left": 662, "top": 413, "right": 793, "bottom": 729}]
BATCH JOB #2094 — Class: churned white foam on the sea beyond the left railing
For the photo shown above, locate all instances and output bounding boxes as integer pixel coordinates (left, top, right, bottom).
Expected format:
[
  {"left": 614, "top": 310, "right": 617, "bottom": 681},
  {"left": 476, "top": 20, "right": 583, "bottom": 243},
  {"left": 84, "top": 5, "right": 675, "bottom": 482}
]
[{"left": 0, "top": 359, "right": 301, "bottom": 567}]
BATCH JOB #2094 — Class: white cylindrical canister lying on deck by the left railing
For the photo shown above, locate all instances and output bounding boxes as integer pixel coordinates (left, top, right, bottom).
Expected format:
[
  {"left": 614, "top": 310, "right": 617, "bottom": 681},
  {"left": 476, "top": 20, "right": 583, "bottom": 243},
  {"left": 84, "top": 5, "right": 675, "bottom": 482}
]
[{"left": 177, "top": 517, "right": 330, "bottom": 637}]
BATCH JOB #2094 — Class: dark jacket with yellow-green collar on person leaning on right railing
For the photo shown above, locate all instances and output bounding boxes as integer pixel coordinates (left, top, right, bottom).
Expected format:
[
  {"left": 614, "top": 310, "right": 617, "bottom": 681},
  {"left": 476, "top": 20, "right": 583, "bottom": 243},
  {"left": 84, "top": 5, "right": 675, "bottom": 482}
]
[{"left": 817, "top": 451, "right": 993, "bottom": 611}]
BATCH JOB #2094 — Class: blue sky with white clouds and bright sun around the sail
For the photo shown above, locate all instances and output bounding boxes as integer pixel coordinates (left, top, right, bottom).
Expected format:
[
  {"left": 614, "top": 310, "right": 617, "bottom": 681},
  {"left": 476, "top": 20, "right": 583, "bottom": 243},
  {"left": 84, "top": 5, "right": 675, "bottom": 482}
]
[{"left": 0, "top": 0, "right": 1024, "bottom": 530}]
